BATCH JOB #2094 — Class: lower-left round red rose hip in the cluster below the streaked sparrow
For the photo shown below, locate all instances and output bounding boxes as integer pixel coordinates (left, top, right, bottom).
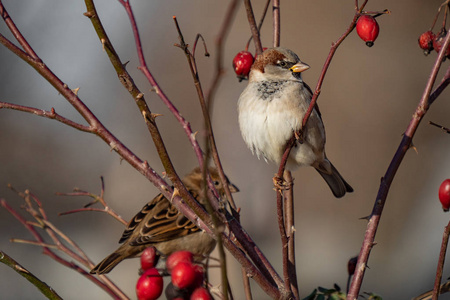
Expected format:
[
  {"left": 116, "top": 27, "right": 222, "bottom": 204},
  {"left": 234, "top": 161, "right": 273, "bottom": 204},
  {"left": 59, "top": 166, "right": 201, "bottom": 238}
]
[{"left": 136, "top": 268, "right": 164, "bottom": 300}]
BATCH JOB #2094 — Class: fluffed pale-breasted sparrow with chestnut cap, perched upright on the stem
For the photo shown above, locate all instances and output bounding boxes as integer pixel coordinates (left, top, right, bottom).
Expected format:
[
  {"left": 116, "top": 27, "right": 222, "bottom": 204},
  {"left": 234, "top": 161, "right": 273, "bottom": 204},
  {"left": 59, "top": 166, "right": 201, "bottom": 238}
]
[{"left": 238, "top": 48, "right": 353, "bottom": 198}]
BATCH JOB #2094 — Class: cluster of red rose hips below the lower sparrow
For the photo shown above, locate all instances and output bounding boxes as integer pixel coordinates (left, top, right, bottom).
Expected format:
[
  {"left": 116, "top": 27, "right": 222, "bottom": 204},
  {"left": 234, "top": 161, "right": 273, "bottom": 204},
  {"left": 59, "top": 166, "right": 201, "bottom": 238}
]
[{"left": 136, "top": 247, "right": 213, "bottom": 300}]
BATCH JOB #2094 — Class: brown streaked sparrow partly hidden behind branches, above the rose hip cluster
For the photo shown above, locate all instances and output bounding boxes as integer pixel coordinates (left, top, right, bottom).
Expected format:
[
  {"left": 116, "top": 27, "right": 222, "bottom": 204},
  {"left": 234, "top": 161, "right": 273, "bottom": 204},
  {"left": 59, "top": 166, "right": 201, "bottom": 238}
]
[{"left": 91, "top": 168, "right": 239, "bottom": 274}]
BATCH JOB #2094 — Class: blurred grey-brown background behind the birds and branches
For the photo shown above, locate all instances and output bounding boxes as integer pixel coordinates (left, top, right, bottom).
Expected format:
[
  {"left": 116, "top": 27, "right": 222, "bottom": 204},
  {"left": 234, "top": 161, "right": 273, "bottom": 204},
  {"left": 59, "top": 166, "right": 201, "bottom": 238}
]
[{"left": 0, "top": 0, "right": 450, "bottom": 299}]
